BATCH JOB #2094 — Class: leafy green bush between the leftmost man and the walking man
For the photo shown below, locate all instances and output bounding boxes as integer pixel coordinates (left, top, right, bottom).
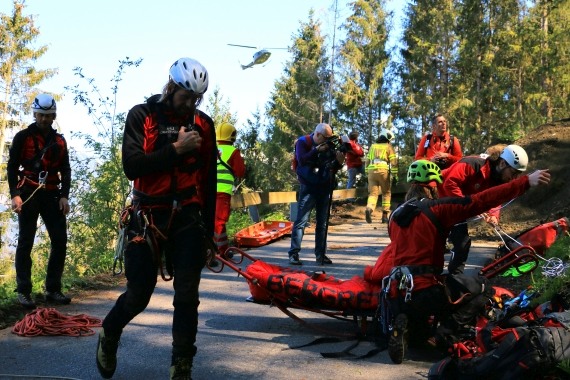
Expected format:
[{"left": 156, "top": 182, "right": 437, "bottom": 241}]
[{"left": 61, "top": 58, "right": 141, "bottom": 276}]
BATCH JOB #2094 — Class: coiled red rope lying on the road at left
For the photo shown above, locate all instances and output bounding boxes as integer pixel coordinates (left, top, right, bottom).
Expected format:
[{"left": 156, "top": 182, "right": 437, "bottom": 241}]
[{"left": 12, "top": 308, "right": 101, "bottom": 337}]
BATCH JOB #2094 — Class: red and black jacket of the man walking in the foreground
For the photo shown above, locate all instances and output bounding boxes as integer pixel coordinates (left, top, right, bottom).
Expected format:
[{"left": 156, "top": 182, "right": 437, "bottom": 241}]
[{"left": 122, "top": 97, "right": 217, "bottom": 235}]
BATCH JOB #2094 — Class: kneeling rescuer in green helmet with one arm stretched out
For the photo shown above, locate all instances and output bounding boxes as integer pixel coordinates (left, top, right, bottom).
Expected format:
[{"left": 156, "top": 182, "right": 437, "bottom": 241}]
[{"left": 364, "top": 160, "right": 550, "bottom": 363}]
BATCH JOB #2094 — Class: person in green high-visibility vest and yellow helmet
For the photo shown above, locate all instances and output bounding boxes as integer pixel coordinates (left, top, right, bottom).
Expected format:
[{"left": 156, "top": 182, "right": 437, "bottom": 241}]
[{"left": 214, "top": 122, "right": 245, "bottom": 255}]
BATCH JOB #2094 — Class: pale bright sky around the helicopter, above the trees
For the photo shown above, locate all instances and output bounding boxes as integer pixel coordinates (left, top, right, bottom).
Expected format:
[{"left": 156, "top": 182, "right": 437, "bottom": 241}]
[{"left": 0, "top": 0, "right": 360, "bottom": 146}]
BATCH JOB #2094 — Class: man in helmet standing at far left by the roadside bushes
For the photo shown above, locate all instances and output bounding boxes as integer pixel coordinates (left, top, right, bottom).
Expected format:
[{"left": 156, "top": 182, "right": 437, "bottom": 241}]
[{"left": 7, "top": 94, "right": 71, "bottom": 309}]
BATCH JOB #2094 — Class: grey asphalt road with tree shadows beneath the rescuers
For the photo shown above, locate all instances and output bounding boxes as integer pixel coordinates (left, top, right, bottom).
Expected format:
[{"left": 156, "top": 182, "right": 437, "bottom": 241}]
[{"left": 0, "top": 222, "right": 496, "bottom": 380}]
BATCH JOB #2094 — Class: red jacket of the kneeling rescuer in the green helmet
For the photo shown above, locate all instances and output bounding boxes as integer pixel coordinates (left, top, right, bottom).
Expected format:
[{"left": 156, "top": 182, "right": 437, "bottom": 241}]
[{"left": 364, "top": 176, "right": 530, "bottom": 291}]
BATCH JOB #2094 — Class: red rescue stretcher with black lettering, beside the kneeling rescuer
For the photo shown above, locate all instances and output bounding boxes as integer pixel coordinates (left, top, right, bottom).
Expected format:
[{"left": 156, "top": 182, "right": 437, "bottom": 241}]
[{"left": 206, "top": 247, "right": 381, "bottom": 337}]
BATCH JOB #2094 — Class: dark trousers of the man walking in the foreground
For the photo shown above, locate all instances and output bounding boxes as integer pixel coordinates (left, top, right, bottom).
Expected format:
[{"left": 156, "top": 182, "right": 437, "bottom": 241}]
[{"left": 103, "top": 209, "right": 206, "bottom": 358}]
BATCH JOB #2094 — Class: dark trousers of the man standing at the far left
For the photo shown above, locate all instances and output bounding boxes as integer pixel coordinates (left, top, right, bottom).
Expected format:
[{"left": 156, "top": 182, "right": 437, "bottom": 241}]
[{"left": 16, "top": 190, "right": 67, "bottom": 294}]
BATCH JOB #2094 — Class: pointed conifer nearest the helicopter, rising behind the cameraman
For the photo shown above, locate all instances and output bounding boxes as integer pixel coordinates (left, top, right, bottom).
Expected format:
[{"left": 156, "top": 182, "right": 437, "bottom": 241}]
[{"left": 260, "top": 11, "right": 330, "bottom": 191}]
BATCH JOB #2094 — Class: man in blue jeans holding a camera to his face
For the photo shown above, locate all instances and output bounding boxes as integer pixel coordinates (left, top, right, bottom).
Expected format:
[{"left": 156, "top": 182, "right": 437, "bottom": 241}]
[{"left": 289, "top": 123, "right": 344, "bottom": 265}]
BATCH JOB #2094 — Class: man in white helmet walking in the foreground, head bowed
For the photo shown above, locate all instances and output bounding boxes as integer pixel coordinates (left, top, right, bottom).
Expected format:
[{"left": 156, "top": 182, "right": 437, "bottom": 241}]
[{"left": 96, "top": 58, "right": 217, "bottom": 379}]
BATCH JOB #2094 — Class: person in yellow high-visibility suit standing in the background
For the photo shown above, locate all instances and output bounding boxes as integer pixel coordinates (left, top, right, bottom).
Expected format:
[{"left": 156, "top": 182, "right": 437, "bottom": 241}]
[{"left": 365, "top": 128, "right": 398, "bottom": 223}]
